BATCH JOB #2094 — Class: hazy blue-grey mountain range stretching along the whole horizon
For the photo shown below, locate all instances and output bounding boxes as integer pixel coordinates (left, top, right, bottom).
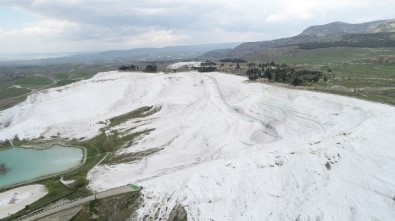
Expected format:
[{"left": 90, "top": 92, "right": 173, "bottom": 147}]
[{"left": 0, "top": 19, "right": 395, "bottom": 65}]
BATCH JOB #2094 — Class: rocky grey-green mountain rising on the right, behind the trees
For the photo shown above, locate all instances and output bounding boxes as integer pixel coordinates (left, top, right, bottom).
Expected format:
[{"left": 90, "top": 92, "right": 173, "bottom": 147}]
[{"left": 200, "top": 20, "right": 395, "bottom": 59}]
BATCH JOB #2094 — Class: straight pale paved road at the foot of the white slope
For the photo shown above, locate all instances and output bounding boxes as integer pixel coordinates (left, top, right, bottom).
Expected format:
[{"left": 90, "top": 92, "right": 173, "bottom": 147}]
[{"left": 17, "top": 185, "right": 139, "bottom": 221}]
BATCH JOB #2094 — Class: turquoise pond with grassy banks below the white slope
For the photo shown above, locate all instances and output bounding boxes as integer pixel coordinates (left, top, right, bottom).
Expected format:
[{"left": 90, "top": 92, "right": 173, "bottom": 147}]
[{"left": 0, "top": 145, "right": 84, "bottom": 188}]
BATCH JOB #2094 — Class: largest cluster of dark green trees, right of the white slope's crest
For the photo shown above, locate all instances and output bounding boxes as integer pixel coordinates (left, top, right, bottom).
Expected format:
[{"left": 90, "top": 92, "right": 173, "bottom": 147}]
[{"left": 246, "top": 62, "right": 323, "bottom": 86}]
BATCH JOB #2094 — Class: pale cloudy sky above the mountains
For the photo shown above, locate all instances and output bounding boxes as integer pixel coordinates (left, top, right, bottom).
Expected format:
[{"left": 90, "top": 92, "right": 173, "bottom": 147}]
[{"left": 0, "top": 0, "right": 395, "bottom": 53}]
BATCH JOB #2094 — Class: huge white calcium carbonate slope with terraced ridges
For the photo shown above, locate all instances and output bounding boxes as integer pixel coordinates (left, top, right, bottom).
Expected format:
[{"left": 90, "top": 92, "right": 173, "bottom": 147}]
[{"left": 0, "top": 72, "right": 395, "bottom": 220}]
